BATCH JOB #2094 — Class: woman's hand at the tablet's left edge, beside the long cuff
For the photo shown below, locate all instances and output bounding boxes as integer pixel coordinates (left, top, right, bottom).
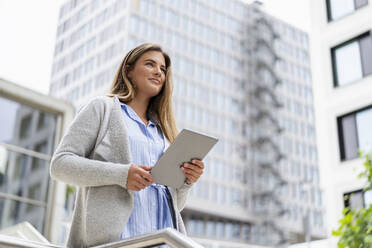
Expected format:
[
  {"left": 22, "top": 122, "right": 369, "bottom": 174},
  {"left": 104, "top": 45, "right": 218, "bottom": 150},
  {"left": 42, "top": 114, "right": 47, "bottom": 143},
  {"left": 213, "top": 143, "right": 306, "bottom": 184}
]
[{"left": 126, "top": 164, "right": 154, "bottom": 191}]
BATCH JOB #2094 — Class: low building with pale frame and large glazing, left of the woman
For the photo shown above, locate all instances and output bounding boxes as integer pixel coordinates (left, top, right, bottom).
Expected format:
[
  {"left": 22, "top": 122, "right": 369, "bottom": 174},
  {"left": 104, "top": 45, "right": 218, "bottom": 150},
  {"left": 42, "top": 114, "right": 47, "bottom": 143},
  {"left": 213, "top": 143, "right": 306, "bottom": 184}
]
[{"left": 0, "top": 79, "right": 74, "bottom": 244}]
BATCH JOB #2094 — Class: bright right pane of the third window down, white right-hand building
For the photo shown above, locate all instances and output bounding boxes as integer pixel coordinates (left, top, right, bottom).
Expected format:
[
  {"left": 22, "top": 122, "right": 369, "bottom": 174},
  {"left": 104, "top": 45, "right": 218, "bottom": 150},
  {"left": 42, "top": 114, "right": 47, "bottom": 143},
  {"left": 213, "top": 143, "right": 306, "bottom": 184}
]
[{"left": 356, "top": 108, "right": 372, "bottom": 152}]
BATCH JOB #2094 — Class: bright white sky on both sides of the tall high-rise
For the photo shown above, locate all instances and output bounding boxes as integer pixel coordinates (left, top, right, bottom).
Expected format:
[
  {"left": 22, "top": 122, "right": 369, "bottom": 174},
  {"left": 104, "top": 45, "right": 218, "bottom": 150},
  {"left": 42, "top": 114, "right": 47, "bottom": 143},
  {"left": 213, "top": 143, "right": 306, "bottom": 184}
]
[{"left": 0, "top": 0, "right": 310, "bottom": 94}]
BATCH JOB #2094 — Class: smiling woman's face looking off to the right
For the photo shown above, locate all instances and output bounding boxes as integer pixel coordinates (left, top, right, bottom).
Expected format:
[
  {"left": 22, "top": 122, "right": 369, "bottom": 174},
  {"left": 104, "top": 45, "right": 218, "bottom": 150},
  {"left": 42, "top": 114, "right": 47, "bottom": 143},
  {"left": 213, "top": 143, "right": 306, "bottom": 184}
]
[{"left": 128, "top": 51, "right": 166, "bottom": 98}]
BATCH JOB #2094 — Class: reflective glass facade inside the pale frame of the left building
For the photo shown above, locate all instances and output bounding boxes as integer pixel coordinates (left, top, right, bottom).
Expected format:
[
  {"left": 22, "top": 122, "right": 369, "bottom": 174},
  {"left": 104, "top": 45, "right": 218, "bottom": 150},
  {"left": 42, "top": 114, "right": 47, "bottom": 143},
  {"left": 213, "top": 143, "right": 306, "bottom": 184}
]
[{"left": 0, "top": 94, "right": 56, "bottom": 233}]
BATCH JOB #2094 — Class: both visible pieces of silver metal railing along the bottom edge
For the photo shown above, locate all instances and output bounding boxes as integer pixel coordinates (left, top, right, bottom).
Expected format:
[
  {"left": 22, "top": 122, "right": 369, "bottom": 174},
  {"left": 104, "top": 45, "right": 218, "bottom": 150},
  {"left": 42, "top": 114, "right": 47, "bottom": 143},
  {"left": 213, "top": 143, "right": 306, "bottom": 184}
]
[{"left": 0, "top": 228, "right": 203, "bottom": 248}]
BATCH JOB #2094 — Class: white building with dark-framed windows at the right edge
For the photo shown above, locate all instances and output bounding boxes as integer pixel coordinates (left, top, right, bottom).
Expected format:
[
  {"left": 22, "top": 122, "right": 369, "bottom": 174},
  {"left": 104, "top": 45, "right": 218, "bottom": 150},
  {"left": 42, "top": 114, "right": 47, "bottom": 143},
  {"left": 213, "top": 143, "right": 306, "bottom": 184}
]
[{"left": 311, "top": 0, "right": 372, "bottom": 240}]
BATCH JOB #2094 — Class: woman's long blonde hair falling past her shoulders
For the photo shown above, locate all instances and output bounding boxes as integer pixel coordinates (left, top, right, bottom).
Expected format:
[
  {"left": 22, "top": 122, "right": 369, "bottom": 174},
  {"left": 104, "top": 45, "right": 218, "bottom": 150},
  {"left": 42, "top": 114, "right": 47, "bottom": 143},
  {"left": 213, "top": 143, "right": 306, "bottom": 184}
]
[{"left": 107, "top": 43, "right": 178, "bottom": 142}]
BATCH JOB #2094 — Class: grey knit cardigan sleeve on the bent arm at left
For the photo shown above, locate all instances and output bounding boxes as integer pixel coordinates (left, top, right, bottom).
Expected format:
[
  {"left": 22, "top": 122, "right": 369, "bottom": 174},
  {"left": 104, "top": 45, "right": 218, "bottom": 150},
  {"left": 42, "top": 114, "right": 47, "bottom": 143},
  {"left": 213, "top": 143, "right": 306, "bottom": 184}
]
[{"left": 50, "top": 98, "right": 130, "bottom": 188}]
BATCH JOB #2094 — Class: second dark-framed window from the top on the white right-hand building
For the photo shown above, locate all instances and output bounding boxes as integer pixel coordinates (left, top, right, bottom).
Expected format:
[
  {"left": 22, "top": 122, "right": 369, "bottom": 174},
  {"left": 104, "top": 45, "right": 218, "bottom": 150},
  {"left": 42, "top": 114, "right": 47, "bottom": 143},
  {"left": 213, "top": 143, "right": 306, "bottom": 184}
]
[{"left": 331, "top": 32, "right": 372, "bottom": 87}]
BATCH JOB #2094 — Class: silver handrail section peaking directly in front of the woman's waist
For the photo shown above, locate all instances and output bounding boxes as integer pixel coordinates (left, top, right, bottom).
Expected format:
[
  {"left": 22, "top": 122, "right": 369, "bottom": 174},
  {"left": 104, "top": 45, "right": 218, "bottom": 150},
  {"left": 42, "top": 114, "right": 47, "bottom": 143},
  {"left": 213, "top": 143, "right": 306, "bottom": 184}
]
[{"left": 92, "top": 228, "right": 203, "bottom": 248}]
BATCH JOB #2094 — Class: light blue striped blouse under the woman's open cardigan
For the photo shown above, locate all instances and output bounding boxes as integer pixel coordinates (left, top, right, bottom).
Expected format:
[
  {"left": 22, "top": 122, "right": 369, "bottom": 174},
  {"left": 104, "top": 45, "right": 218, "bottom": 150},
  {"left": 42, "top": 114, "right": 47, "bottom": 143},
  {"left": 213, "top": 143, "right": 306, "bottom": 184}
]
[{"left": 120, "top": 103, "right": 173, "bottom": 242}]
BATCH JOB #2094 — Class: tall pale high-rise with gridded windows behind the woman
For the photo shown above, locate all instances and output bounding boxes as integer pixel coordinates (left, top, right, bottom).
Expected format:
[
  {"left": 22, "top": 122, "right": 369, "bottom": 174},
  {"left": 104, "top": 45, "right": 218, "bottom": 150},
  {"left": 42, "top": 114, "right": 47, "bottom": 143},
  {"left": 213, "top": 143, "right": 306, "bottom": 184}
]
[{"left": 50, "top": 0, "right": 325, "bottom": 248}]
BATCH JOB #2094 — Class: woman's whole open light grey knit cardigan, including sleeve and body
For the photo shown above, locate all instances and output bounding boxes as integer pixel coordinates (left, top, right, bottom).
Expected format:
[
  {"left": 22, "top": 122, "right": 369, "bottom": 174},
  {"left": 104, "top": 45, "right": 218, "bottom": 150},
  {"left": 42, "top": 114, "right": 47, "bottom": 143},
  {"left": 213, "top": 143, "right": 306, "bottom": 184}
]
[{"left": 50, "top": 97, "right": 190, "bottom": 248}]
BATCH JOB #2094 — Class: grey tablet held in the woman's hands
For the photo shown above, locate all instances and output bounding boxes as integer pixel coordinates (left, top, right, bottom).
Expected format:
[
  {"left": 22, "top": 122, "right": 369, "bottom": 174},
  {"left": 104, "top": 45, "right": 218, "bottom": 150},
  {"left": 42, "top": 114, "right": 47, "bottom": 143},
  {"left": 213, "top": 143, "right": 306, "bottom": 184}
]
[{"left": 151, "top": 129, "right": 218, "bottom": 188}]
